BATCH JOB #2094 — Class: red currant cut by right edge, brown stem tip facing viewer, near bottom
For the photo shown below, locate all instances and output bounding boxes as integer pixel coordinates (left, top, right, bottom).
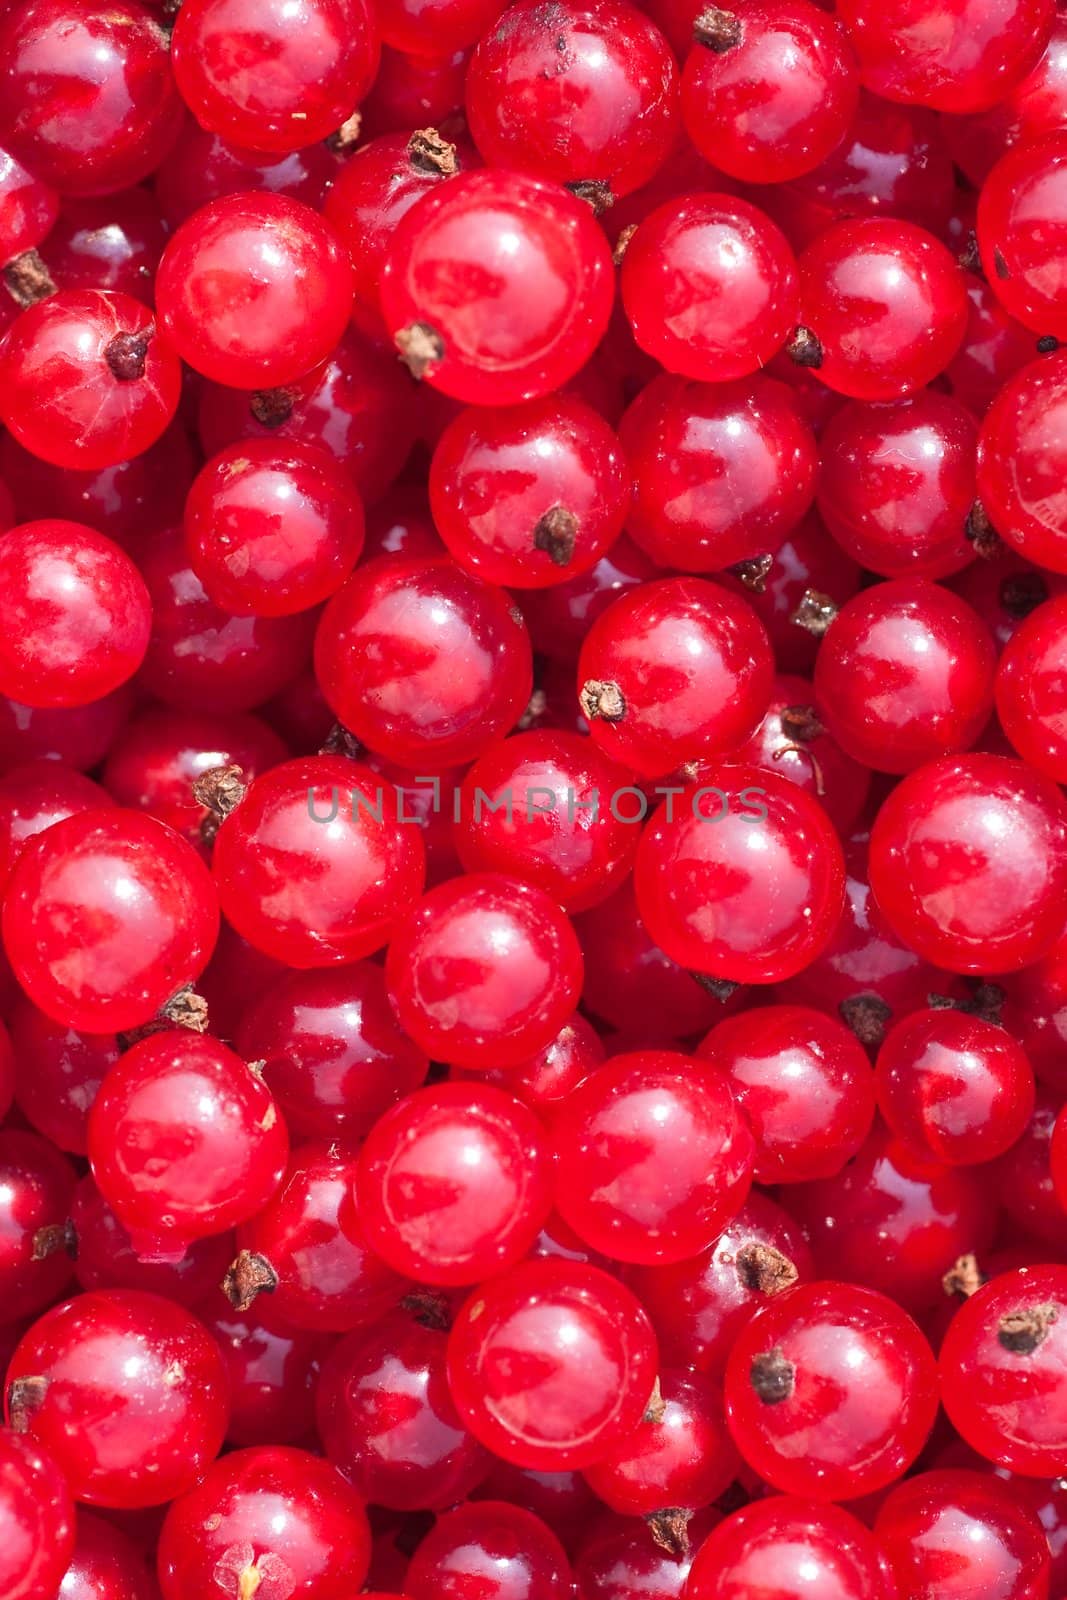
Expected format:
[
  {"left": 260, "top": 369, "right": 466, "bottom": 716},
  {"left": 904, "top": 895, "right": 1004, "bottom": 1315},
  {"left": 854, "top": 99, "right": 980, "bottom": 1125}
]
[{"left": 941, "top": 1266, "right": 1067, "bottom": 1478}]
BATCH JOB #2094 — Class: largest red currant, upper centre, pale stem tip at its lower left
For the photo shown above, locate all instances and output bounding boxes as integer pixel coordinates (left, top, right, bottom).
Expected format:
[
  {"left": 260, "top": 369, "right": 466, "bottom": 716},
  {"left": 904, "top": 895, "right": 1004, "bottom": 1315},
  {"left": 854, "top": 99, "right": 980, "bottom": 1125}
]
[{"left": 382, "top": 170, "right": 614, "bottom": 405}]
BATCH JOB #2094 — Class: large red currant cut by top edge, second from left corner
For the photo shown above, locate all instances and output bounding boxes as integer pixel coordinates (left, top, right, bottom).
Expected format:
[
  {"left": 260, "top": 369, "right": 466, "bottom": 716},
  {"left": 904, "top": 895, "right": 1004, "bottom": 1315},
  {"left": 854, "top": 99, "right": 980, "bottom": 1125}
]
[{"left": 171, "top": 0, "right": 378, "bottom": 152}]
